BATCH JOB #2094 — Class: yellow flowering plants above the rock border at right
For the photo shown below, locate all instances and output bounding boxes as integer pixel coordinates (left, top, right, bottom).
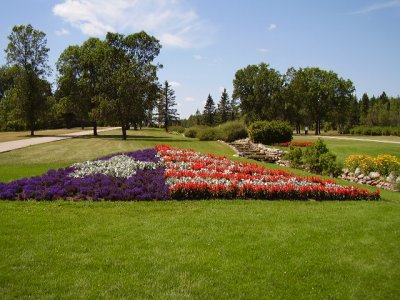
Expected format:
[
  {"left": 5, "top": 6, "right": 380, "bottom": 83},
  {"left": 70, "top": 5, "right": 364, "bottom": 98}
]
[{"left": 344, "top": 154, "right": 400, "bottom": 176}]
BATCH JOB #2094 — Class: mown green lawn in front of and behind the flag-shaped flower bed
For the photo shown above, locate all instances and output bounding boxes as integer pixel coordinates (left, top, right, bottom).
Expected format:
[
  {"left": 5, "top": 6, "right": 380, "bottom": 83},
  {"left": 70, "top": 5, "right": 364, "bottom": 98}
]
[{"left": 0, "top": 130, "right": 400, "bottom": 299}]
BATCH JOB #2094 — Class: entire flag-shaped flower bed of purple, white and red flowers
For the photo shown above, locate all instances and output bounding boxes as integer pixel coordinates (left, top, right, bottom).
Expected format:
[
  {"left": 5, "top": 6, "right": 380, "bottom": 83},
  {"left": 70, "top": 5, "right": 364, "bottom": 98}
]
[{"left": 0, "top": 145, "right": 379, "bottom": 201}]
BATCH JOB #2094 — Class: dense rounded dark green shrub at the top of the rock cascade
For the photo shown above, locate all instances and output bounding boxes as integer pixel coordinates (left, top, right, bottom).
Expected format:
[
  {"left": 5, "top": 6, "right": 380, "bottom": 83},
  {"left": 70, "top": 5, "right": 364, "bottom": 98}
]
[{"left": 249, "top": 121, "right": 293, "bottom": 145}]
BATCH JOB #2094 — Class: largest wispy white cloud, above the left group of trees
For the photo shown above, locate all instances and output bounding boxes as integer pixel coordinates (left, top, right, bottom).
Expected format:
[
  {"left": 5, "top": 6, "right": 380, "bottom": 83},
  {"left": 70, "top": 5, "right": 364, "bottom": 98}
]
[{"left": 53, "top": 0, "right": 214, "bottom": 48}]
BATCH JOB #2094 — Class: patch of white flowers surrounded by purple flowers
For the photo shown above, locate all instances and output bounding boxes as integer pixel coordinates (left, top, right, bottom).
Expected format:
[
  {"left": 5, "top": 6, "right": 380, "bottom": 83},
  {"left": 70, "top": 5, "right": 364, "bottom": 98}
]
[{"left": 69, "top": 154, "right": 163, "bottom": 178}]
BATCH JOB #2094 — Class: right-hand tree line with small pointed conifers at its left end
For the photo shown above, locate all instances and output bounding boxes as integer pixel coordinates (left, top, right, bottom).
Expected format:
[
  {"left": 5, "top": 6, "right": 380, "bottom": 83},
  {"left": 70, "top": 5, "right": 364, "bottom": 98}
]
[{"left": 188, "top": 63, "right": 400, "bottom": 134}]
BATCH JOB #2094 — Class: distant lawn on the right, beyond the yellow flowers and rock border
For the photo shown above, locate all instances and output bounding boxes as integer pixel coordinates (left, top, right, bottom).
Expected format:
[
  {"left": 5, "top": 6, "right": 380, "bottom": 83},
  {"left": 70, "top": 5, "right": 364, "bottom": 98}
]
[{"left": 293, "top": 135, "right": 400, "bottom": 162}]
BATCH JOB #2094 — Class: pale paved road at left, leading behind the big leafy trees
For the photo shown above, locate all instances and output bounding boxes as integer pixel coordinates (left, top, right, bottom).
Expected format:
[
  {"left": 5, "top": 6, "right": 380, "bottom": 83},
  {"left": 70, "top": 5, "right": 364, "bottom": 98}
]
[{"left": 0, "top": 127, "right": 121, "bottom": 153}]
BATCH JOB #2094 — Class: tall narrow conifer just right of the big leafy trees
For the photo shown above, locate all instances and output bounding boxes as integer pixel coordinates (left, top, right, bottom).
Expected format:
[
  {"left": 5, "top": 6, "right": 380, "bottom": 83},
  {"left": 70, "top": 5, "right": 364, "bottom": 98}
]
[{"left": 158, "top": 81, "right": 179, "bottom": 131}]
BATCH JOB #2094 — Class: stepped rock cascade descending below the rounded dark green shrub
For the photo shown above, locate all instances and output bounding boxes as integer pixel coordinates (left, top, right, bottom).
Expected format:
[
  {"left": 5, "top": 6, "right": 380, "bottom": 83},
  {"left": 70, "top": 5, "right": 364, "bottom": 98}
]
[{"left": 229, "top": 138, "right": 289, "bottom": 166}]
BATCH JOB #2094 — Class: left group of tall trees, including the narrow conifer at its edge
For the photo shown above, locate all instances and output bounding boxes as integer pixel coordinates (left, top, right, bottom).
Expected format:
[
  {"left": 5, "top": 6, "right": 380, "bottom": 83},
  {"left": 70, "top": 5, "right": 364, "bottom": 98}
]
[{"left": 0, "top": 25, "right": 178, "bottom": 139}]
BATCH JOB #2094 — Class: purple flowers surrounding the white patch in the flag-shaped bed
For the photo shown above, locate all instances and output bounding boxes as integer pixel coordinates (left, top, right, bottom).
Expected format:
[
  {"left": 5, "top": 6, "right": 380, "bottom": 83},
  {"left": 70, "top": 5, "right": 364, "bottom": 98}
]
[{"left": 0, "top": 149, "right": 170, "bottom": 201}]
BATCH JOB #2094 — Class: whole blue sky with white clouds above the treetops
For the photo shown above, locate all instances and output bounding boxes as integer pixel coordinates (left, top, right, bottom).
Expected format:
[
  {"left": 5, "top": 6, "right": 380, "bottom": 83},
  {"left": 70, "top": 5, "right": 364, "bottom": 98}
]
[{"left": 0, "top": 0, "right": 400, "bottom": 117}]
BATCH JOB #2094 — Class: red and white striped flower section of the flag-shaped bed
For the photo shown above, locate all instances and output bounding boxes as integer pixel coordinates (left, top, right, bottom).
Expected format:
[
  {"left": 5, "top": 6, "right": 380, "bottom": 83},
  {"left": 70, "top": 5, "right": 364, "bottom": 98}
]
[{"left": 156, "top": 145, "right": 379, "bottom": 200}]
